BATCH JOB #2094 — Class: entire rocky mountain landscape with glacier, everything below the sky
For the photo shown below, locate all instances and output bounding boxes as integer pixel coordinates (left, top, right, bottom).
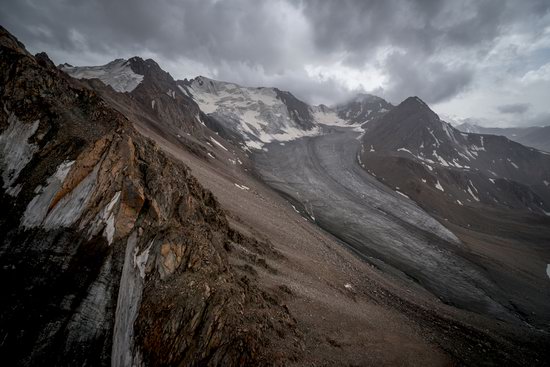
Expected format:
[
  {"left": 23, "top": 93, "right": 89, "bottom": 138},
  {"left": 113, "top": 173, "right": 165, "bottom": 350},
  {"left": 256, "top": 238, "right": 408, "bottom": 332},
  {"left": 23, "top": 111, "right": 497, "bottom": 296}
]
[{"left": 0, "top": 27, "right": 550, "bottom": 366}]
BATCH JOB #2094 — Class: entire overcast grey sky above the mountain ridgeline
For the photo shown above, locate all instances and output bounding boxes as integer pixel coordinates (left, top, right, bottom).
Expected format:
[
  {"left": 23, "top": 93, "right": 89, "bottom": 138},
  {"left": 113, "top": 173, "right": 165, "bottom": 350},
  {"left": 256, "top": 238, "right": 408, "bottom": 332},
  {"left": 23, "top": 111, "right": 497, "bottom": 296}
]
[{"left": 0, "top": 0, "right": 550, "bottom": 126}]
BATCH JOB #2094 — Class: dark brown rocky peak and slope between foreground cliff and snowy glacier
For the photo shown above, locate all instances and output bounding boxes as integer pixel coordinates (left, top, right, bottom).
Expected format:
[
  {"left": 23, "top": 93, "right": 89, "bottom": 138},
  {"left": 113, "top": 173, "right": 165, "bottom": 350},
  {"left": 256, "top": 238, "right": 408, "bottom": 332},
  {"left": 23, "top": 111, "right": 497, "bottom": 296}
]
[{"left": 60, "top": 57, "right": 252, "bottom": 172}]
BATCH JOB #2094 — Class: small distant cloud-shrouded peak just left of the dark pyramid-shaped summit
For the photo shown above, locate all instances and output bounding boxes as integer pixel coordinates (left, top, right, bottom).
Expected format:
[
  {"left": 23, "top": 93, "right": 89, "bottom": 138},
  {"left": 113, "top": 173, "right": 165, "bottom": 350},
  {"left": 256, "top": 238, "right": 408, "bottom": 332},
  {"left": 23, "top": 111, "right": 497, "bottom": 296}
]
[{"left": 336, "top": 94, "right": 393, "bottom": 124}]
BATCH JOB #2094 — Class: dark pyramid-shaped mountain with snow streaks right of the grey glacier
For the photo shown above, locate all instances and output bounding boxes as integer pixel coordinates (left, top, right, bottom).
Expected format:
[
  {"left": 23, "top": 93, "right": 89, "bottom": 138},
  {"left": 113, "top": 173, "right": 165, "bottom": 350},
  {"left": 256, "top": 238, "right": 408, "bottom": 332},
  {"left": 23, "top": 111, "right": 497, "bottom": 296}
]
[{"left": 359, "top": 97, "right": 550, "bottom": 325}]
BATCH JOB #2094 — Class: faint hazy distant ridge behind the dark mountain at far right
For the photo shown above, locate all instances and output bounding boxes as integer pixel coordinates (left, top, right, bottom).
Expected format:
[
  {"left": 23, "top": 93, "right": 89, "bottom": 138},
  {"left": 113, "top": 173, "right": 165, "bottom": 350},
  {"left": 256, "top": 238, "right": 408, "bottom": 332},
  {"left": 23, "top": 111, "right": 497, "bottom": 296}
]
[{"left": 456, "top": 122, "right": 550, "bottom": 152}]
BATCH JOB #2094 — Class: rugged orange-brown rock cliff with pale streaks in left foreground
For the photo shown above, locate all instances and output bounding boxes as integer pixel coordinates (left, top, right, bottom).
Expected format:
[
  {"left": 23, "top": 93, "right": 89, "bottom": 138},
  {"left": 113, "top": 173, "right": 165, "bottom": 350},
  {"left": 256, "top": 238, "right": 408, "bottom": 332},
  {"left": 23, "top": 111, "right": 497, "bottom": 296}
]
[{"left": 0, "top": 28, "right": 300, "bottom": 366}]
